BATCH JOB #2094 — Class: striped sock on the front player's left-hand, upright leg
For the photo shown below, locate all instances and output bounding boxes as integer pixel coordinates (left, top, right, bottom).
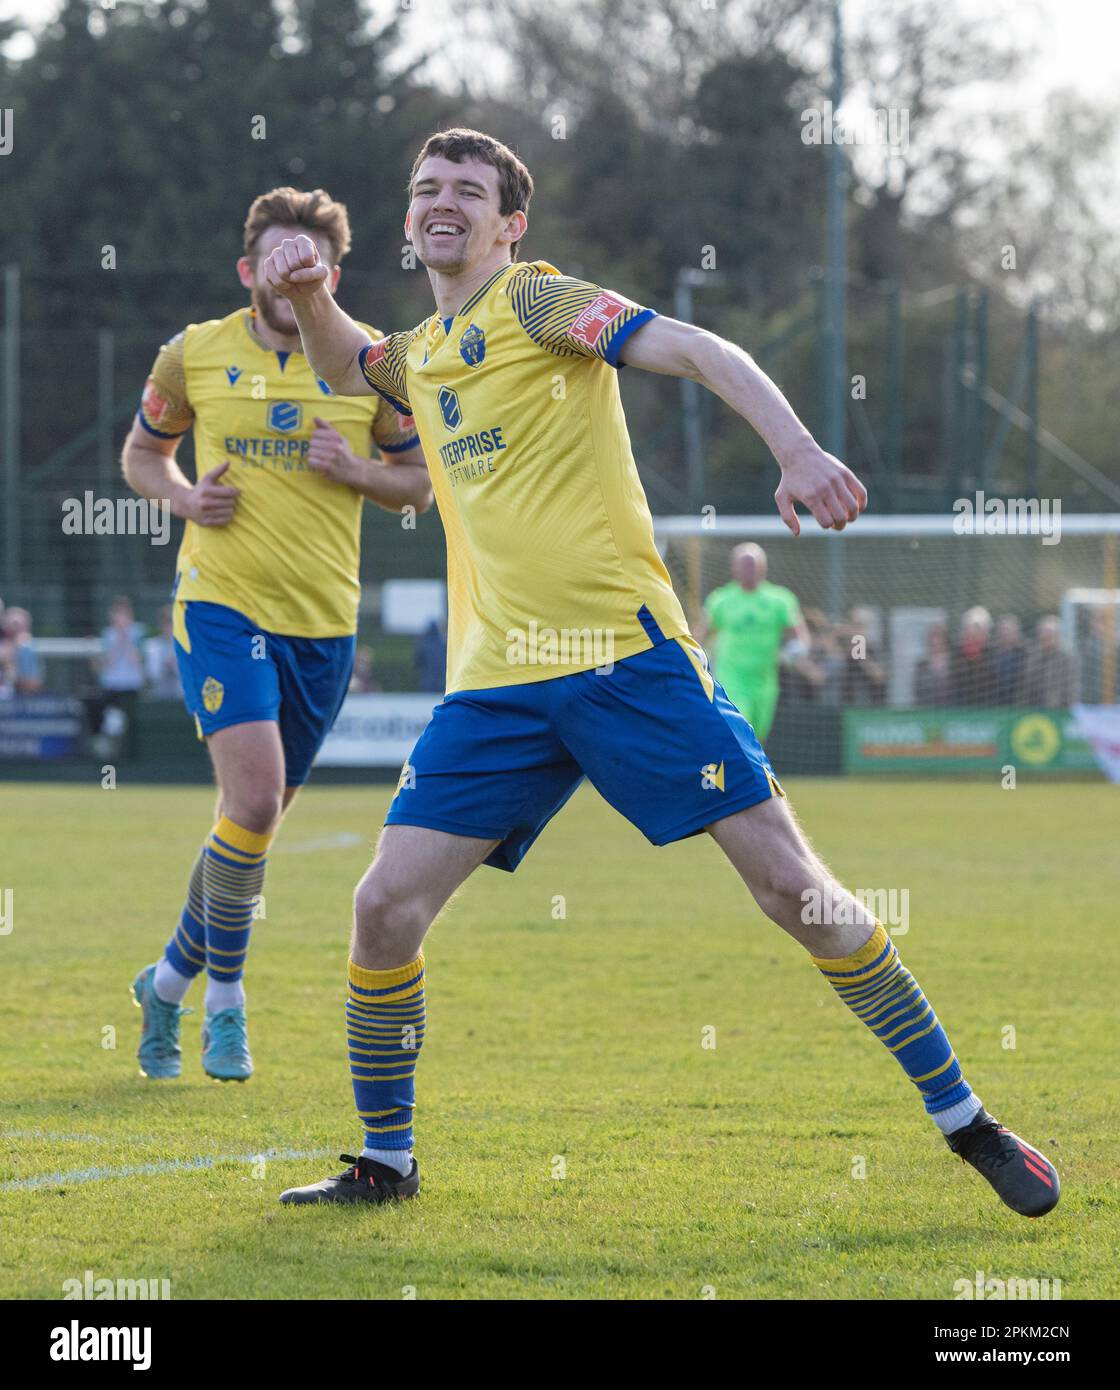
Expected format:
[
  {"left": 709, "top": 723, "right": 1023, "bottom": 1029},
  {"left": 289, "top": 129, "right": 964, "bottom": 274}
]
[{"left": 346, "top": 951, "right": 427, "bottom": 1150}]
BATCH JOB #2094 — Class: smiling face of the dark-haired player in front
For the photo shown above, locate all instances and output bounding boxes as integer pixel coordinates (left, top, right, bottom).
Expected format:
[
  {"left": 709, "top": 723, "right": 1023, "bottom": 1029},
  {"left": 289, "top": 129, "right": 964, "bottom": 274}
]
[{"left": 404, "top": 154, "right": 527, "bottom": 275}]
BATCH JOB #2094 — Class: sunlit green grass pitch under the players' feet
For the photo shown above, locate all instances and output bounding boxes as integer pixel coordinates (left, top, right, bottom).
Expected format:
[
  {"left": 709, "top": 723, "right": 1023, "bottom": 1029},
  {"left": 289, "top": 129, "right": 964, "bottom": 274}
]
[{"left": 0, "top": 780, "right": 1120, "bottom": 1300}]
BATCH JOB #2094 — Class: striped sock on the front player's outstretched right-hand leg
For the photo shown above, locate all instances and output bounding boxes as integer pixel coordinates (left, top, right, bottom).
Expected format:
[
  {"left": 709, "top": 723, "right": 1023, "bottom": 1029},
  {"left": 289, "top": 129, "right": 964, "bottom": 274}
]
[{"left": 812, "top": 922, "right": 980, "bottom": 1134}]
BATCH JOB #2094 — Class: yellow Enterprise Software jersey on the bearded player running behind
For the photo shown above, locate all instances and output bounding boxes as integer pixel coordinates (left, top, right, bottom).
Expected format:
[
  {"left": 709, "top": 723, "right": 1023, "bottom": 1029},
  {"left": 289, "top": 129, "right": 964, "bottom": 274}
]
[{"left": 139, "top": 309, "right": 417, "bottom": 637}]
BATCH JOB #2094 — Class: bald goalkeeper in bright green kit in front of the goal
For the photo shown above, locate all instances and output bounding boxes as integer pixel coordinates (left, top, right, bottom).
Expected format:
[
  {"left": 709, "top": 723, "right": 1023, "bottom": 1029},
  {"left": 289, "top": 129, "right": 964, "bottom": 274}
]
[{"left": 696, "top": 542, "right": 809, "bottom": 742}]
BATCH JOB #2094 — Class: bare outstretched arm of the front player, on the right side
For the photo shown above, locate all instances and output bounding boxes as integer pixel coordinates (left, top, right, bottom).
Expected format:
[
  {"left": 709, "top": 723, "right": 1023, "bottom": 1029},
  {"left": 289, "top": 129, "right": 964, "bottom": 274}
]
[{"left": 620, "top": 318, "right": 867, "bottom": 535}]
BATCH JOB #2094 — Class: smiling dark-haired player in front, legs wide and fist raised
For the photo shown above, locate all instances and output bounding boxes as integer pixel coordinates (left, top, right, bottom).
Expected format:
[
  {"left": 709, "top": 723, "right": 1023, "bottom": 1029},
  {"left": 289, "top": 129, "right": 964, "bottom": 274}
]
[{"left": 265, "top": 131, "right": 1059, "bottom": 1216}]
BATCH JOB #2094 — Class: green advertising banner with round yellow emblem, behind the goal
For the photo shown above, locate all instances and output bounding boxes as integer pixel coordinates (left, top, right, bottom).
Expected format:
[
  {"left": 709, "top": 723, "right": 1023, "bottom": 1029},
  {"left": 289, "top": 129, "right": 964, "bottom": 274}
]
[{"left": 843, "top": 709, "right": 1098, "bottom": 773}]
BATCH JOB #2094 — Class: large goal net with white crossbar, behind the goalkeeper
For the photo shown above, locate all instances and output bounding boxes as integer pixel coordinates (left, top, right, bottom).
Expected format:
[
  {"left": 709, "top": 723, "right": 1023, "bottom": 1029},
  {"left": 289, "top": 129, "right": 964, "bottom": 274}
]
[{"left": 654, "top": 513, "right": 1120, "bottom": 771}]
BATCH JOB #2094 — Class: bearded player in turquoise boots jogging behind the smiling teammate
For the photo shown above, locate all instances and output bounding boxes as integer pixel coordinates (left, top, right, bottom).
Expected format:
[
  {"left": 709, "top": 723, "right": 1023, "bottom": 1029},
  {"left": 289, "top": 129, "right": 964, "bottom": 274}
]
[{"left": 122, "top": 188, "right": 431, "bottom": 1081}]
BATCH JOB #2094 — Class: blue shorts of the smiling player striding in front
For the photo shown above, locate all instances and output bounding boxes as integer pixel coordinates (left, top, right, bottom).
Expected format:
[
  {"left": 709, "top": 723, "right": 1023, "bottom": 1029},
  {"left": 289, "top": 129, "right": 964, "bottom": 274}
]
[{"left": 385, "top": 637, "right": 785, "bottom": 872}]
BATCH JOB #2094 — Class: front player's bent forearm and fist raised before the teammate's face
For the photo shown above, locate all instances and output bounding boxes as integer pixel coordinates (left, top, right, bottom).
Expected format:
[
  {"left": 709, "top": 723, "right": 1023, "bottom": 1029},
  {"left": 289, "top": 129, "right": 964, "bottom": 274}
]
[{"left": 264, "top": 236, "right": 374, "bottom": 396}]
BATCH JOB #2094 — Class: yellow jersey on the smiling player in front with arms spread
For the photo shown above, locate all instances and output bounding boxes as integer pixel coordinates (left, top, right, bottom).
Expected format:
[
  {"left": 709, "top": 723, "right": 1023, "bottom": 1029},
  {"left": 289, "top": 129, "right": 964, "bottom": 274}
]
[{"left": 360, "top": 261, "right": 688, "bottom": 692}]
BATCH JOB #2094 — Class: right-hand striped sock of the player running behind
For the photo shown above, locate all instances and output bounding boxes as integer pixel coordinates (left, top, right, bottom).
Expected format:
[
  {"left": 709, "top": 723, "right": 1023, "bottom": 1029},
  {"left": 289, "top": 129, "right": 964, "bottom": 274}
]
[{"left": 203, "top": 816, "right": 272, "bottom": 1011}]
